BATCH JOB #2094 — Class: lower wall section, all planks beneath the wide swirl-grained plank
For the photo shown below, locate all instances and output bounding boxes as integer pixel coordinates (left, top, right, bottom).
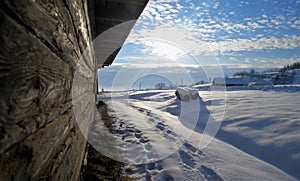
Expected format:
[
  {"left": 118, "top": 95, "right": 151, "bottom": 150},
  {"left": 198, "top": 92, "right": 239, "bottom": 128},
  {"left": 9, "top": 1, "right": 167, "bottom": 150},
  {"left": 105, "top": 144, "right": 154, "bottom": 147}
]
[{"left": 0, "top": 110, "right": 86, "bottom": 180}]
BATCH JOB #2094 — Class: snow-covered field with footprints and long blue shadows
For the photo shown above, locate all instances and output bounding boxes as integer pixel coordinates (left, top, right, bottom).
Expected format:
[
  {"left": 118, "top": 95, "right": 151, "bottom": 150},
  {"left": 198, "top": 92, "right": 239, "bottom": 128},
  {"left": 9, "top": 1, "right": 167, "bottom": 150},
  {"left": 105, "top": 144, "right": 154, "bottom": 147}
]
[{"left": 94, "top": 86, "right": 300, "bottom": 180}]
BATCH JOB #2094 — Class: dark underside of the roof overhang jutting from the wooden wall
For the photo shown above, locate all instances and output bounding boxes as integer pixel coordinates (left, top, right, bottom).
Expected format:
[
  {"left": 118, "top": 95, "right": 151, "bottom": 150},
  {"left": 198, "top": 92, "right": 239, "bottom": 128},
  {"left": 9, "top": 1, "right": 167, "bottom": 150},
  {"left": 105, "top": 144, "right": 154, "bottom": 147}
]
[{"left": 89, "top": 0, "right": 149, "bottom": 68}]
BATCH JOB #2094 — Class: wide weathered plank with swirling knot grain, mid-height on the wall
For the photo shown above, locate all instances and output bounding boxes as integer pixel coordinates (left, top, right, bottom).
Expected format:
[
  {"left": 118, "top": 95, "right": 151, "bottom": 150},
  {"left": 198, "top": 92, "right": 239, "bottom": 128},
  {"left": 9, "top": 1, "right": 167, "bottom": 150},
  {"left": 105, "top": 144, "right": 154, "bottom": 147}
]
[{"left": 0, "top": 10, "right": 73, "bottom": 126}]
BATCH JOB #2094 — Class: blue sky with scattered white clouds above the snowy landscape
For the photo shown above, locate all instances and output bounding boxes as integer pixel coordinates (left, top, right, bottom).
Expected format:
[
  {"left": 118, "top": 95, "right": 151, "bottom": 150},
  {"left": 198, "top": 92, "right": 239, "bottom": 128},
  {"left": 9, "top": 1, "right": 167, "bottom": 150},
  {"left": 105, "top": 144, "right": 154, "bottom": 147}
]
[{"left": 100, "top": 0, "right": 300, "bottom": 90}]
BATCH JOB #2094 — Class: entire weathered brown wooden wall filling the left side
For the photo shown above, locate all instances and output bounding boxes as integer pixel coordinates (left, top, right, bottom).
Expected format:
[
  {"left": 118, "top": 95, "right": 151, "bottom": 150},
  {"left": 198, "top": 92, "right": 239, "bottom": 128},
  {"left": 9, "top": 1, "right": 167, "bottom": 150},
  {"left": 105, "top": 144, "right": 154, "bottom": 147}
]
[{"left": 0, "top": 0, "right": 96, "bottom": 181}]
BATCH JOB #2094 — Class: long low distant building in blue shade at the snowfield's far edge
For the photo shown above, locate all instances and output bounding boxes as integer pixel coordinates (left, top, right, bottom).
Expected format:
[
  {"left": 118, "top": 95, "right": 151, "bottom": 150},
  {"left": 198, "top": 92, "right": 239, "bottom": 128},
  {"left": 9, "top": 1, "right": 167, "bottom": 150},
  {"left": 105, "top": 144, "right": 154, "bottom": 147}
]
[{"left": 212, "top": 77, "right": 251, "bottom": 86}]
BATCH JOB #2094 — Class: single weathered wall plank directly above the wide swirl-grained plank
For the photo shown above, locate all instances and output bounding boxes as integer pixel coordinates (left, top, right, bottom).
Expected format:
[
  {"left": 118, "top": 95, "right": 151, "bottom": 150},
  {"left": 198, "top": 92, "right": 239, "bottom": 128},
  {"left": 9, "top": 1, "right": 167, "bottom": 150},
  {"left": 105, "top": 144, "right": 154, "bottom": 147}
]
[{"left": 5, "top": 0, "right": 80, "bottom": 67}]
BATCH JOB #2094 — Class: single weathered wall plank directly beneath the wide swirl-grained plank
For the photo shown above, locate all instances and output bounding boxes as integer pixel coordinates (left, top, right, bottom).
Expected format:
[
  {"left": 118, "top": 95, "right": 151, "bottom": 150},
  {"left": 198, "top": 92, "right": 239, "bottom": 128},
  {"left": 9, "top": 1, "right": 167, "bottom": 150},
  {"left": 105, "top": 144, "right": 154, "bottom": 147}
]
[{"left": 0, "top": 111, "right": 74, "bottom": 180}]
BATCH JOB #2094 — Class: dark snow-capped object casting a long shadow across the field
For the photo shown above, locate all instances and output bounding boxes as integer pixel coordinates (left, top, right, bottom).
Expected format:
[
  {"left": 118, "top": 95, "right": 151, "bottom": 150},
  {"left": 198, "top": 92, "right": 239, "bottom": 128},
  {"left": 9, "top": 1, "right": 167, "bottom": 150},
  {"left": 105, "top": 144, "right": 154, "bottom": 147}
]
[{"left": 176, "top": 87, "right": 199, "bottom": 101}]
